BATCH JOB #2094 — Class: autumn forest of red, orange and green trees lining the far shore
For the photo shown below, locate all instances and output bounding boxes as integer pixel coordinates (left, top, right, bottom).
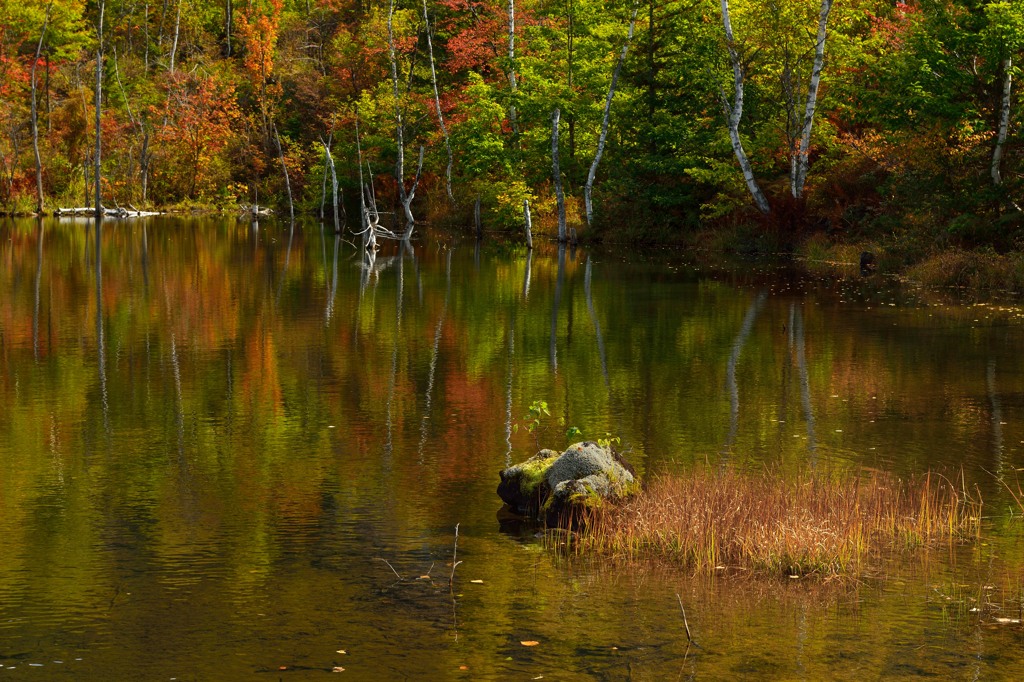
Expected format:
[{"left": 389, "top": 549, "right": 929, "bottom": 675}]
[{"left": 0, "top": 0, "right": 1024, "bottom": 244}]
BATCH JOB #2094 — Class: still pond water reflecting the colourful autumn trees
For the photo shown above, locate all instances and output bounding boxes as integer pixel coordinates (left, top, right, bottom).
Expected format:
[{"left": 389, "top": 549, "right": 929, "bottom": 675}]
[{"left": 0, "top": 218, "right": 1024, "bottom": 680}]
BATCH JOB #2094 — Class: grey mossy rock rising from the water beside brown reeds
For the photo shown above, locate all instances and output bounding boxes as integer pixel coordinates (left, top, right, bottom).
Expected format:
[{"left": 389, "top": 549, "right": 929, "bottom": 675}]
[{"left": 498, "top": 441, "right": 637, "bottom": 525}]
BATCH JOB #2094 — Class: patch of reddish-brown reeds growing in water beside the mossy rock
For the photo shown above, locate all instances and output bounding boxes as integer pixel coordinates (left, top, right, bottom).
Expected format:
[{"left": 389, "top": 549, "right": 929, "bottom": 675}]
[{"left": 570, "top": 469, "right": 981, "bottom": 578}]
